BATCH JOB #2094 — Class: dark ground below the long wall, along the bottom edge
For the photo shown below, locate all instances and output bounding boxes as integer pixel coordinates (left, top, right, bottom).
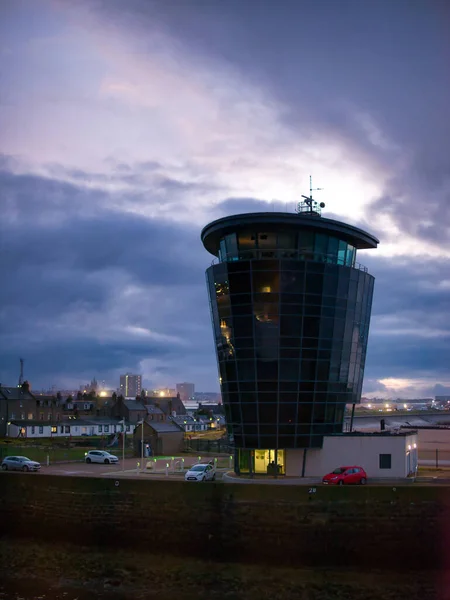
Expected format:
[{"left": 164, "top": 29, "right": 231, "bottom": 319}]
[{"left": 0, "top": 532, "right": 442, "bottom": 600}]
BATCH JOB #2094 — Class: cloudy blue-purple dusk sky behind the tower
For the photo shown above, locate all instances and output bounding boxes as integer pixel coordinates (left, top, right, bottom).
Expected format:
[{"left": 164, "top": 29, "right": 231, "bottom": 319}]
[{"left": 0, "top": 0, "right": 450, "bottom": 398}]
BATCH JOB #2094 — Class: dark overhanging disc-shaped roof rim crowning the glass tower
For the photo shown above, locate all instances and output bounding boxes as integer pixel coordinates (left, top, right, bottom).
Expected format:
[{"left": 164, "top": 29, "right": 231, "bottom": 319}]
[{"left": 201, "top": 212, "right": 380, "bottom": 256}]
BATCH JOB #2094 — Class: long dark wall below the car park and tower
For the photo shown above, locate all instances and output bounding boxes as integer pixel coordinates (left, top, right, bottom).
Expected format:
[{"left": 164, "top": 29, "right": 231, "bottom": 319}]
[{"left": 0, "top": 474, "right": 450, "bottom": 570}]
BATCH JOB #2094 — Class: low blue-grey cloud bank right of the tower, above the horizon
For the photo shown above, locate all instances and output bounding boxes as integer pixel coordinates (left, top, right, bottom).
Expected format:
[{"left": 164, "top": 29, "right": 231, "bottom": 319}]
[{"left": 364, "top": 254, "right": 450, "bottom": 383}]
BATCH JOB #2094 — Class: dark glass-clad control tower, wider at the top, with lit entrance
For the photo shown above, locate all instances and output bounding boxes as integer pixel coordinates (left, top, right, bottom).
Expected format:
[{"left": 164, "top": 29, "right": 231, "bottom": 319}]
[{"left": 201, "top": 204, "right": 378, "bottom": 474}]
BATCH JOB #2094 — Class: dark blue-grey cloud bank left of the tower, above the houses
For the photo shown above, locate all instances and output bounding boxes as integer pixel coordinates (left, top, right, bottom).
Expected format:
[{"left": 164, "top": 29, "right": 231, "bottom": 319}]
[{"left": 0, "top": 165, "right": 215, "bottom": 385}]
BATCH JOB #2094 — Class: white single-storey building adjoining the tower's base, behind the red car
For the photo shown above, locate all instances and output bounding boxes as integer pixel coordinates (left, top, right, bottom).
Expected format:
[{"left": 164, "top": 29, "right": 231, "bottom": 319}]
[{"left": 284, "top": 431, "right": 418, "bottom": 478}]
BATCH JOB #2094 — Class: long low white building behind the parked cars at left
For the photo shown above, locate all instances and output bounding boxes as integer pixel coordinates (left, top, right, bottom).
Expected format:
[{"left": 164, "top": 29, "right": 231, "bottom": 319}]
[{"left": 7, "top": 417, "right": 135, "bottom": 438}]
